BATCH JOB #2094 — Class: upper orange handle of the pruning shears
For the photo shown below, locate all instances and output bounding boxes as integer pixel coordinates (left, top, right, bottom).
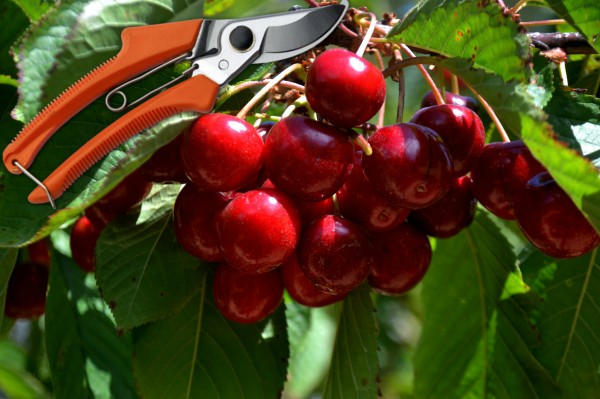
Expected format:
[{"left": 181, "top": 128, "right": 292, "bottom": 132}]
[{"left": 3, "top": 19, "right": 202, "bottom": 174}]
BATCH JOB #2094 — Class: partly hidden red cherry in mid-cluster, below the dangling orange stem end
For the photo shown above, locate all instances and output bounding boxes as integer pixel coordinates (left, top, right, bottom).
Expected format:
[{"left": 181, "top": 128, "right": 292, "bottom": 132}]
[{"left": 337, "top": 151, "right": 410, "bottom": 231}]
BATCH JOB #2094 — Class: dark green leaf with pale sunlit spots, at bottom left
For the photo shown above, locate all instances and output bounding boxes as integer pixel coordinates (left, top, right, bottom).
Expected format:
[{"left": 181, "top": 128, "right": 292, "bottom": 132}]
[{"left": 45, "top": 251, "right": 137, "bottom": 399}]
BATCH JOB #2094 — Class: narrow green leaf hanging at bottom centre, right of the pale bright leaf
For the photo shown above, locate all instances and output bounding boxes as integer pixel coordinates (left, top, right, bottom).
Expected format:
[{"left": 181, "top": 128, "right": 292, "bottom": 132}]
[{"left": 323, "top": 285, "right": 379, "bottom": 399}]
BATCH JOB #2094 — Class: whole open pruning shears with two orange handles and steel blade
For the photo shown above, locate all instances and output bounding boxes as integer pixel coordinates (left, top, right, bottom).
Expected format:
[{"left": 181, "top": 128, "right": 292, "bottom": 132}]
[{"left": 3, "top": 0, "right": 348, "bottom": 207}]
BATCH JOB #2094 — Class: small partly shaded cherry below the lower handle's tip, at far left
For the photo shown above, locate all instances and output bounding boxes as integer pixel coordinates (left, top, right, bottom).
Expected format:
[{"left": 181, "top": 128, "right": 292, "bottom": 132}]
[{"left": 71, "top": 216, "right": 104, "bottom": 272}]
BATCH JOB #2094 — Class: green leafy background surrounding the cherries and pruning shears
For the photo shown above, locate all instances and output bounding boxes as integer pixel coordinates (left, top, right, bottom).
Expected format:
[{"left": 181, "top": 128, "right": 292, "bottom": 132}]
[{"left": 0, "top": 0, "right": 600, "bottom": 399}]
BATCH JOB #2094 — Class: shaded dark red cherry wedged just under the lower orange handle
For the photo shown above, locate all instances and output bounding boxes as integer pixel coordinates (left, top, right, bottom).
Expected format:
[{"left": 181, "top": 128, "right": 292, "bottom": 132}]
[{"left": 140, "top": 134, "right": 190, "bottom": 184}]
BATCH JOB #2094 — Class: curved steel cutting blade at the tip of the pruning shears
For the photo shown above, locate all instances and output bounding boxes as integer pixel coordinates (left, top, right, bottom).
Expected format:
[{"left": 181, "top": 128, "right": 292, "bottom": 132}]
[{"left": 254, "top": 1, "right": 348, "bottom": 64}]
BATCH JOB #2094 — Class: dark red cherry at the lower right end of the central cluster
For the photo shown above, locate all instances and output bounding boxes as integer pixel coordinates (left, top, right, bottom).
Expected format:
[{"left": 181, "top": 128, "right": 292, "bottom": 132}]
[{"left": 369, "top": 223, "right": 431, "bottom": 296}]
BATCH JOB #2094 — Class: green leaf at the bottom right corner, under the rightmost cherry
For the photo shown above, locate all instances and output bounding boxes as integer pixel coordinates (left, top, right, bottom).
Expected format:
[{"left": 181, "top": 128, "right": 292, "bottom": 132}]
[{"left": 522, "top": 249, "right": 600, "bottom": 398}]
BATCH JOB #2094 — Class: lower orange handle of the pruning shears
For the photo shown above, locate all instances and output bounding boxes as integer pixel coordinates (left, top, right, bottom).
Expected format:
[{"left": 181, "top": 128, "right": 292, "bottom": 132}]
[{"left": 28, "top": 75, "right": 220, "bottom": 204}]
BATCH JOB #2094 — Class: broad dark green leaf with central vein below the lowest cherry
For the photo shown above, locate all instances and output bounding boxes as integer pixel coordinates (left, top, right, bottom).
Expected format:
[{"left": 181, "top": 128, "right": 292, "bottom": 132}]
[{"left": 134, "top": 273, "right": 287, "bottom": 399}]
